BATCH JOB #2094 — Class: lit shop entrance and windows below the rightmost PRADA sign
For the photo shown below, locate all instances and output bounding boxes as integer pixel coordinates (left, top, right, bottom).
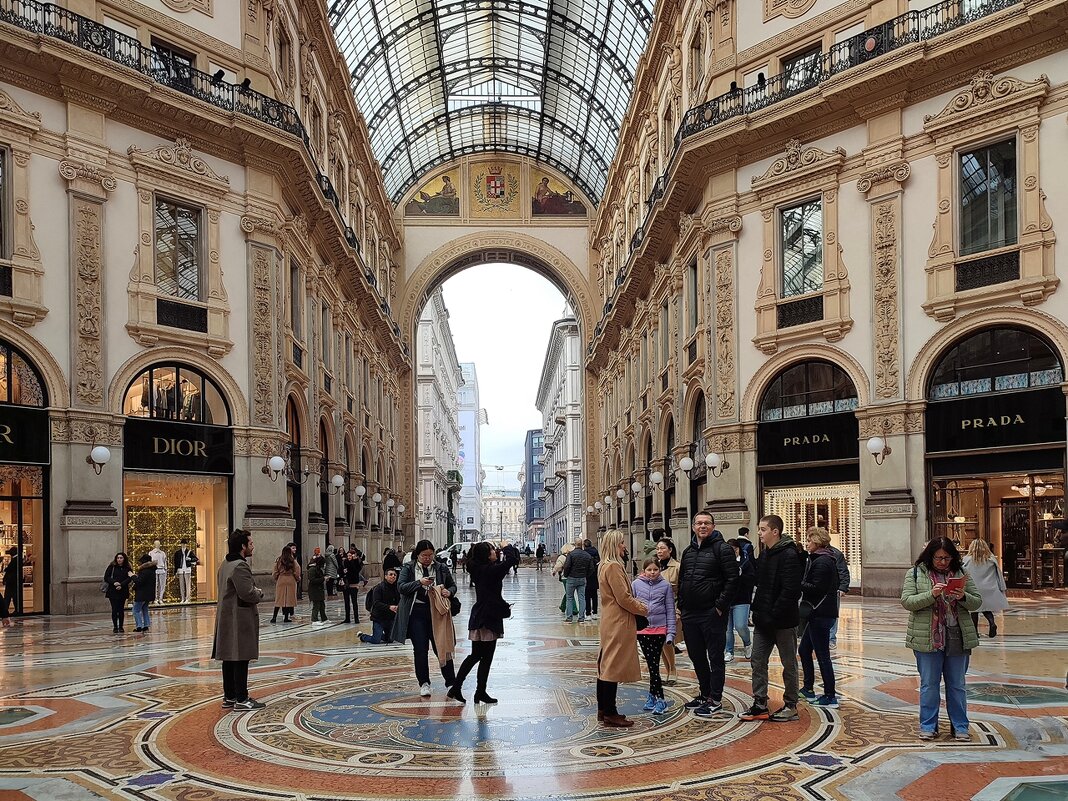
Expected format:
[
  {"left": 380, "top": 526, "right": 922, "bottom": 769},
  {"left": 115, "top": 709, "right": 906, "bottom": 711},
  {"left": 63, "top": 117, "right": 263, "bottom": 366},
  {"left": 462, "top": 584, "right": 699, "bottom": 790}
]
[{"left": 930, "top": 470, "right": 1065, "bottom": 590}]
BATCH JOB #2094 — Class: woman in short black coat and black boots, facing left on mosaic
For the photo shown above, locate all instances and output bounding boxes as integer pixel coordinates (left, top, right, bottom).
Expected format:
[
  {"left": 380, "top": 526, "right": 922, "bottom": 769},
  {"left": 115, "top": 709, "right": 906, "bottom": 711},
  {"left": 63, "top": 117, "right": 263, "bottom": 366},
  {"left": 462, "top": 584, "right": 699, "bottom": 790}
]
[{"left": 447, "top": 543, "right": 513, "bottom": 704}]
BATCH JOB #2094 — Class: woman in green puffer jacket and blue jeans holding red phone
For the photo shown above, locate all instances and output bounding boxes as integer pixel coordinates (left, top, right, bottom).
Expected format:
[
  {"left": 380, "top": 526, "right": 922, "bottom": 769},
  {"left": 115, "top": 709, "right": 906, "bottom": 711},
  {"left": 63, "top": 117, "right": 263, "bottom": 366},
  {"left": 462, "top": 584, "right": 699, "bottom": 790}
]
[{"left": 901, "top": 537, "right": 983, "bottom": 741}]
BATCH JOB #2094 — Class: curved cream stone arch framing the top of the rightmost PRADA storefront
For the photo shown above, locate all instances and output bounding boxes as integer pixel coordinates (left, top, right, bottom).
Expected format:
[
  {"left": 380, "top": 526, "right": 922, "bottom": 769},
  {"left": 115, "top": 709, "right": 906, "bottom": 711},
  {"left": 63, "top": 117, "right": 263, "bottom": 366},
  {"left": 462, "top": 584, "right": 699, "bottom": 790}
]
[{"left": 905, "top": 307, "right": 1068, "bottom": 401}]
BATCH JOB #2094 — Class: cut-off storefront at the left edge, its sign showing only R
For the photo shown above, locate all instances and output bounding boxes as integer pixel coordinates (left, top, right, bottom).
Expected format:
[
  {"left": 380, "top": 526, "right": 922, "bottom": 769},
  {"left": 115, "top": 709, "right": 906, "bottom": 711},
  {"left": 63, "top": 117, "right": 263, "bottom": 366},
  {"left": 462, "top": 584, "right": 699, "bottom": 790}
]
[{"left": 0, "top": 341, "right": 51, "bottom": 614}]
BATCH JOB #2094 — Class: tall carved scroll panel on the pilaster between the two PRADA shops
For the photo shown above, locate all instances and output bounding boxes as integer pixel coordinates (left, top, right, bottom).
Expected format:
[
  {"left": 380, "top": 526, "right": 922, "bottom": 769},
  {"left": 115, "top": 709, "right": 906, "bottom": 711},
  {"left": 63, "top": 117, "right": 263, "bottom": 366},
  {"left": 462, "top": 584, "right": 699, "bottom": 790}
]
[{"left": 873, "top": 200, "right": 901, "bottom": 399}]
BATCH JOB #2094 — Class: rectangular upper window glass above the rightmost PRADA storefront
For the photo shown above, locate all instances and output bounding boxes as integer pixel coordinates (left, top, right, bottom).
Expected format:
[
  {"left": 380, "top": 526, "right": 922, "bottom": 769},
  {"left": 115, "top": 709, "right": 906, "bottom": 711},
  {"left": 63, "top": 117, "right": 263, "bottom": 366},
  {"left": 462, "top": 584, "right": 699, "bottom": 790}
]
[{"left": 960, "top": 139, "right": 1017, "bottom": 256}]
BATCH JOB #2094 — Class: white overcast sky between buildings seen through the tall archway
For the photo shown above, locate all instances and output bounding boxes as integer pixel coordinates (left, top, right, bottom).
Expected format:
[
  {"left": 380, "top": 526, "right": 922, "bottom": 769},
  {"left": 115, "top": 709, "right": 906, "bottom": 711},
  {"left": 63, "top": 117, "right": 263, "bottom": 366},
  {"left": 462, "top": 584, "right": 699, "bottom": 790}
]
[{"left": 442, "top": 264, "right": 565, "bottom": 489}]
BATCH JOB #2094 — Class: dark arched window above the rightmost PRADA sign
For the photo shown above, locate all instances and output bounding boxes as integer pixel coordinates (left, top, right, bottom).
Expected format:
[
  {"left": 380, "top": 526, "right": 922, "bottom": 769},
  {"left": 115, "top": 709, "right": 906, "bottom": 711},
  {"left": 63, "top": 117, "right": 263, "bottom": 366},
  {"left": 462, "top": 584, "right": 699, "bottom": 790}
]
[{"left": 927, "top": 328, "right": 1064, "bottom": 401}]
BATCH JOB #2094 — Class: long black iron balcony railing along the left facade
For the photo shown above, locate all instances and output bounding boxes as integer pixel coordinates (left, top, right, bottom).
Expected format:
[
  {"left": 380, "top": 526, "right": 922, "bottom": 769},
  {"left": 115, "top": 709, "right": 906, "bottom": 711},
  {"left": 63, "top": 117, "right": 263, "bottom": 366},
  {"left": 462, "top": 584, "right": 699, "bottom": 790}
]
[{"left": 0, "top": 0, "right": 408, "bottom": 348}]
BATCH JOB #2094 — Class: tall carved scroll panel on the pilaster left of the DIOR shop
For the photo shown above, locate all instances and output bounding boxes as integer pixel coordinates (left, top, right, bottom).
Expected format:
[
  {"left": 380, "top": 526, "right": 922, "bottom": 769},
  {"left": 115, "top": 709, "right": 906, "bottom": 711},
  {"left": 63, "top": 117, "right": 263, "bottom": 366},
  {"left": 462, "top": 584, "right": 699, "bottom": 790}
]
[{"left": 70, "top": 203, "right": 104, "bottom": 407}]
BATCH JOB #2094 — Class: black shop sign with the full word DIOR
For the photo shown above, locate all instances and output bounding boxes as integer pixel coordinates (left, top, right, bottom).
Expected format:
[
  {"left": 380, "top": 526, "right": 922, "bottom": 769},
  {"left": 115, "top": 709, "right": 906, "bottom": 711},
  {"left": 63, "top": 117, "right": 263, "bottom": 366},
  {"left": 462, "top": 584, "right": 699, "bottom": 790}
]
[{"left": 123, "top": 418, "right": 234, "bottom": 475}]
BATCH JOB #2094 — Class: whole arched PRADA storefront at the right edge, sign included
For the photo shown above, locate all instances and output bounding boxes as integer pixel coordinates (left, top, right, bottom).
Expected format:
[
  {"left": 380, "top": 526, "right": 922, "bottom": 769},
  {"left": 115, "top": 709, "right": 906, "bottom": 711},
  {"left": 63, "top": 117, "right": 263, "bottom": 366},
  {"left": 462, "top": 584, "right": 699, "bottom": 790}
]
[{"left": 925, "top": 328, "right": 1065, "bottom": 590}]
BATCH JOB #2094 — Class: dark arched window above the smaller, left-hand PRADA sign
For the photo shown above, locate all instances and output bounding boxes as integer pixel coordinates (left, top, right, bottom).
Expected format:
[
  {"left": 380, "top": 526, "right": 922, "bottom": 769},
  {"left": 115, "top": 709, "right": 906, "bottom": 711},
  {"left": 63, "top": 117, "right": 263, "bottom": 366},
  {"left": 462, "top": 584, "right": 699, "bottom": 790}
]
[{"left": 760, "top": 361, "right": 857, "bottom": 422}]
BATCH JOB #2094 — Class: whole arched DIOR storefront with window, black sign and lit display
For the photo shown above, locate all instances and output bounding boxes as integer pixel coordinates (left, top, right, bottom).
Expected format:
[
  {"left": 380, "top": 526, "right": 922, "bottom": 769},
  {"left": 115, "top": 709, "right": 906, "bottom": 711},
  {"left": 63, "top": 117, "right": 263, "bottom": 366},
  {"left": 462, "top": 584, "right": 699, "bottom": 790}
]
[{"left": 123, "top": 364, "right": 234, "bottom": 603}]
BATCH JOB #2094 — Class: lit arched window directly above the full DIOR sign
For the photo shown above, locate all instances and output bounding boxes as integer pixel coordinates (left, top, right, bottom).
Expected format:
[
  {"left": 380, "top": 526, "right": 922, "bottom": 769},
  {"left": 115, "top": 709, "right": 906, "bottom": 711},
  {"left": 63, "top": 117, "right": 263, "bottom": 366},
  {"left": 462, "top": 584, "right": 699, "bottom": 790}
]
[{"left": 123, "top": 364, "right": 230, "bottom": 425}]
